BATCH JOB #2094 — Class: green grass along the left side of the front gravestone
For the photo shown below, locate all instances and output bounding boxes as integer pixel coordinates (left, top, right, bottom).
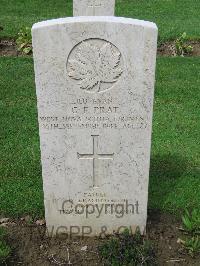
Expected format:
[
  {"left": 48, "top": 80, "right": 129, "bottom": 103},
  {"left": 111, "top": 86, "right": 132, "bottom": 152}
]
[{"left": 0, "top": 58, "right": 43, "bottom": 215}]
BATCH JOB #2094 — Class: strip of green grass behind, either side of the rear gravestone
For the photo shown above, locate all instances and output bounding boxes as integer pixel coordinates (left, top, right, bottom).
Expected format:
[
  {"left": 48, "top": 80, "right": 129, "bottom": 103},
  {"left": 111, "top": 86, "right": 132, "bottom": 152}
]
[{"left": 0, "top": 0, "right": 200, "bottom": 42}]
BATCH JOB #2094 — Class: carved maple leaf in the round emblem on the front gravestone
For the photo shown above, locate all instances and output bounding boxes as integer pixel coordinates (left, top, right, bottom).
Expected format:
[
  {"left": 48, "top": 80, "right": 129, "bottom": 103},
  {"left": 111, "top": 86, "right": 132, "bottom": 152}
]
[{"left": 68, "top": 41, "right": 122, "bottom": 92}]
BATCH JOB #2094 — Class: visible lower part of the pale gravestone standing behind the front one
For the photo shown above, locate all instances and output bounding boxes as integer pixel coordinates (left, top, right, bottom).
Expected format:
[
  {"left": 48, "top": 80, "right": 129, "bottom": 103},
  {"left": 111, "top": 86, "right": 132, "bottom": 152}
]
[{"left": 73, "top": 0, "right": 115, "bottom": 17}]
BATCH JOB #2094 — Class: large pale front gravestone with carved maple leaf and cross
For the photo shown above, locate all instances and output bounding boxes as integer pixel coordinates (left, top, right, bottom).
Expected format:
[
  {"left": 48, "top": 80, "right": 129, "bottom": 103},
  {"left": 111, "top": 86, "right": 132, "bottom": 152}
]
[{"left": 32, "top": 17, "right": 157, "bottom": 236}]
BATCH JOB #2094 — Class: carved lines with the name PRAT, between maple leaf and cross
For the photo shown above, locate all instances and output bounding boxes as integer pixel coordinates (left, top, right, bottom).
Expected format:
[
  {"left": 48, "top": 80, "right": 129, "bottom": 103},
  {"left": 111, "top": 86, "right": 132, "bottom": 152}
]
[{"left": 39, "top": 97, "right": 147, "bottom": 130}]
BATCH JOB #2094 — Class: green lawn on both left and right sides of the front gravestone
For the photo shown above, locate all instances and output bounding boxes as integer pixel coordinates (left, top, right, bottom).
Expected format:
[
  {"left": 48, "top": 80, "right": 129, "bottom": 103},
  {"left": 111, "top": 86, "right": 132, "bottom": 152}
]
[{"left": 0, "top": 57, "right": 200, "bottom": 216}]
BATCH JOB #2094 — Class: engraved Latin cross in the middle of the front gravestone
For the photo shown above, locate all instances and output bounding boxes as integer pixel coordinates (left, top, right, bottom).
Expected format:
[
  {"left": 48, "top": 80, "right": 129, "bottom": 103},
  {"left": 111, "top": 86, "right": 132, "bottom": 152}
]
[{"left": 77, "top": 135, "right": 114, "bottom": 187}]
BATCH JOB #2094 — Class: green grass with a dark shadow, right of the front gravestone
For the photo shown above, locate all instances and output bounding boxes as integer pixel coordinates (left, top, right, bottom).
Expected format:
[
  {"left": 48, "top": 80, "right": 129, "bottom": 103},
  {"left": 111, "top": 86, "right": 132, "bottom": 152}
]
[{"left": 149, "top": 58, "right": 200, "bottom": 212}]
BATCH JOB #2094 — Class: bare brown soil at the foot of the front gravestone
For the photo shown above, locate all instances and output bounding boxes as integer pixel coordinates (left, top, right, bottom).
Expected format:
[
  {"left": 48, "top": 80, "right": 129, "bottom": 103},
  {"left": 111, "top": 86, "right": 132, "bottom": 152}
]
[{"left": 1, "top": 211, "right": 200, "bottom": 266}]
